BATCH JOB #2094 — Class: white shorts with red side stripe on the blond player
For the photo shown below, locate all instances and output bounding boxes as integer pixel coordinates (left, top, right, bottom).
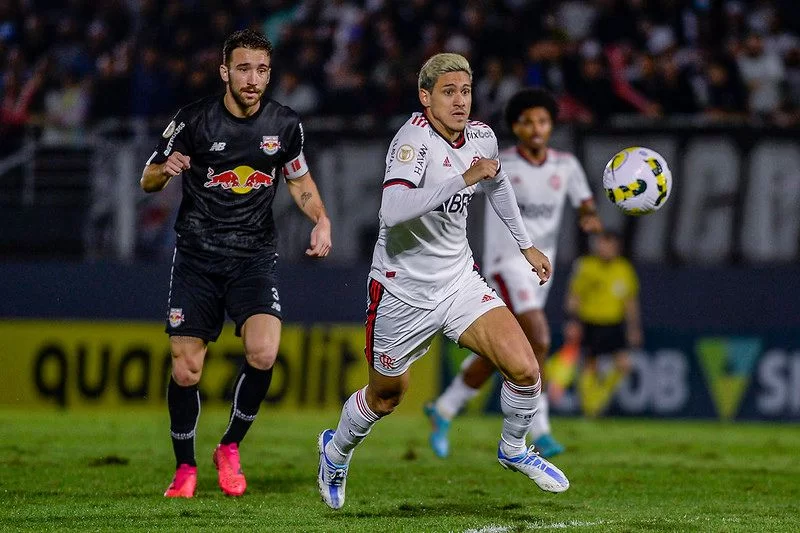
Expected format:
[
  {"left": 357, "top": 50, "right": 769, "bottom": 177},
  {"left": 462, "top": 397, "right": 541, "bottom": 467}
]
[{"left": 364, "top": 271, "right": 505, "bottom": 376}]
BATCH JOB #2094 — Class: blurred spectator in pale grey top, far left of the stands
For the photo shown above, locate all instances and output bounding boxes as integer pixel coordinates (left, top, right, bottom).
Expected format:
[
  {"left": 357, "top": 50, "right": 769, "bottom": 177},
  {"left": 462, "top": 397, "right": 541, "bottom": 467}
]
[{"left": 41, "top": 66, "right": 91, "bottom": 144}]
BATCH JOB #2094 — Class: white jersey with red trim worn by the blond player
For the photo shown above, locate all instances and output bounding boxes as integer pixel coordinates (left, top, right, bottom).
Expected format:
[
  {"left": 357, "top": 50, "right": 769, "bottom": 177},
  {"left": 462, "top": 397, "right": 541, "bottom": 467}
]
[{"left": 370, "top": 113, "right": 500, "bottom": 309}]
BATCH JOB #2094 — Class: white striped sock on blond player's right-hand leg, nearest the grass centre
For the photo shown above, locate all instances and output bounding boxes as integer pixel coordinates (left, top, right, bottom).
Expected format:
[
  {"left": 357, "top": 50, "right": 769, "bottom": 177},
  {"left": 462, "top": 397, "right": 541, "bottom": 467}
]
[{"left": 500, "top": 378, "right": 542, "bottom": 457}]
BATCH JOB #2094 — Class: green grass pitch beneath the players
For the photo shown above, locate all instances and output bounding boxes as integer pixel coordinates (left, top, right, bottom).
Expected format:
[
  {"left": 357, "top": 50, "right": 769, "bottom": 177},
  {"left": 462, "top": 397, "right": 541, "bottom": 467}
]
[{"left": 0, "top": 407, "right": 800, "bottom": 533}]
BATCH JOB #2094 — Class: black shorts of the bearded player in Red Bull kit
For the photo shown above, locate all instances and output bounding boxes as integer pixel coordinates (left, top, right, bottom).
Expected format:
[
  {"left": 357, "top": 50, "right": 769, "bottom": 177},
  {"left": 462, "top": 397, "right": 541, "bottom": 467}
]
[{"left": 165, "top": 249, "right": 282, "bottom": 342}]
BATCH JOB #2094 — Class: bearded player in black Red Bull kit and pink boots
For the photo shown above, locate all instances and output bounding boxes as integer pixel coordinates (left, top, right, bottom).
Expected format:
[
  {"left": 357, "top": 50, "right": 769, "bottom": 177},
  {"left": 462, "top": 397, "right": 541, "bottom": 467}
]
[{"left": 141, "top": 30, "right": 331, "bottom": 498}]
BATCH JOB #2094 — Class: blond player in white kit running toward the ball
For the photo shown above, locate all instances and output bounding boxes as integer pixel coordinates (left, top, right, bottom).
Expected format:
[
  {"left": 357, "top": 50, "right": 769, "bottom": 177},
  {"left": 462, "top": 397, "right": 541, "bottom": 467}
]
[{"left": 318, "top": 54, "right": 569, "bottom": 509}]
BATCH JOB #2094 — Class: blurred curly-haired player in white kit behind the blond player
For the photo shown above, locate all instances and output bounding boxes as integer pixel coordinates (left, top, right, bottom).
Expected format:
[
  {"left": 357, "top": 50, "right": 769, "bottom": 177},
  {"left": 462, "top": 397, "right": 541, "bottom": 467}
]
[{"left": 425, "top": 89, "right": 602, "bottom": 457}]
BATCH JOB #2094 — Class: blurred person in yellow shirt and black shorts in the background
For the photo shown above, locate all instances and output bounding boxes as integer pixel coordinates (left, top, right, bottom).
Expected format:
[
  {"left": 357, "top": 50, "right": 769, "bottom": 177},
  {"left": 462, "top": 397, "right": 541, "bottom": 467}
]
[{"left": 566, "top": 231, "right": 643, "bottom": 416}]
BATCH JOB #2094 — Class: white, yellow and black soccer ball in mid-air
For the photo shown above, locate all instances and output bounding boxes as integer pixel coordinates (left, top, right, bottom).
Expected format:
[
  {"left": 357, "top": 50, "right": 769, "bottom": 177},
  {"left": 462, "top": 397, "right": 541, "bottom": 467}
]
[{"left": 603, "top": 146, "right": 672, "bottom": 216}]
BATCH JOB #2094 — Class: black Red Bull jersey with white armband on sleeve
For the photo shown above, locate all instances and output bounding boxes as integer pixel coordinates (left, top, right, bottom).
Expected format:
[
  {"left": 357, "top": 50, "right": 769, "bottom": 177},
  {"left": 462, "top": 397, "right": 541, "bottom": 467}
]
[{"left": 147, "top": 95, "right": 308, "bottom": 257}]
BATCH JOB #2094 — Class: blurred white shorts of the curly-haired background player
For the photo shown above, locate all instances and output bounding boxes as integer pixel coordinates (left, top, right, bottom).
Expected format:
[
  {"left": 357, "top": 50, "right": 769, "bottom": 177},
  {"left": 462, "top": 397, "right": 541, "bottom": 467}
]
[{"left": 486, "top": 260, "right": 553, "bottom": 315}]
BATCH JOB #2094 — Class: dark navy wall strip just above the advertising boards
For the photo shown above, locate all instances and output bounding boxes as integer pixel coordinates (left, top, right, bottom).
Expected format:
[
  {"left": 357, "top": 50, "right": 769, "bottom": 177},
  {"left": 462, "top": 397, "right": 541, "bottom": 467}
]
[{"left": 0, "top": 261, "right": 800, "bottom": 332}]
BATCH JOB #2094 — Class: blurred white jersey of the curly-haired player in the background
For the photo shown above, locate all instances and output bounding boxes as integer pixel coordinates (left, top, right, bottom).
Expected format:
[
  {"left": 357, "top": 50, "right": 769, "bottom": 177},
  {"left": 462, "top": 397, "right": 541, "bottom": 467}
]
[{"left": 481, "top": 147, "right": 592, "bottom": 273}]
